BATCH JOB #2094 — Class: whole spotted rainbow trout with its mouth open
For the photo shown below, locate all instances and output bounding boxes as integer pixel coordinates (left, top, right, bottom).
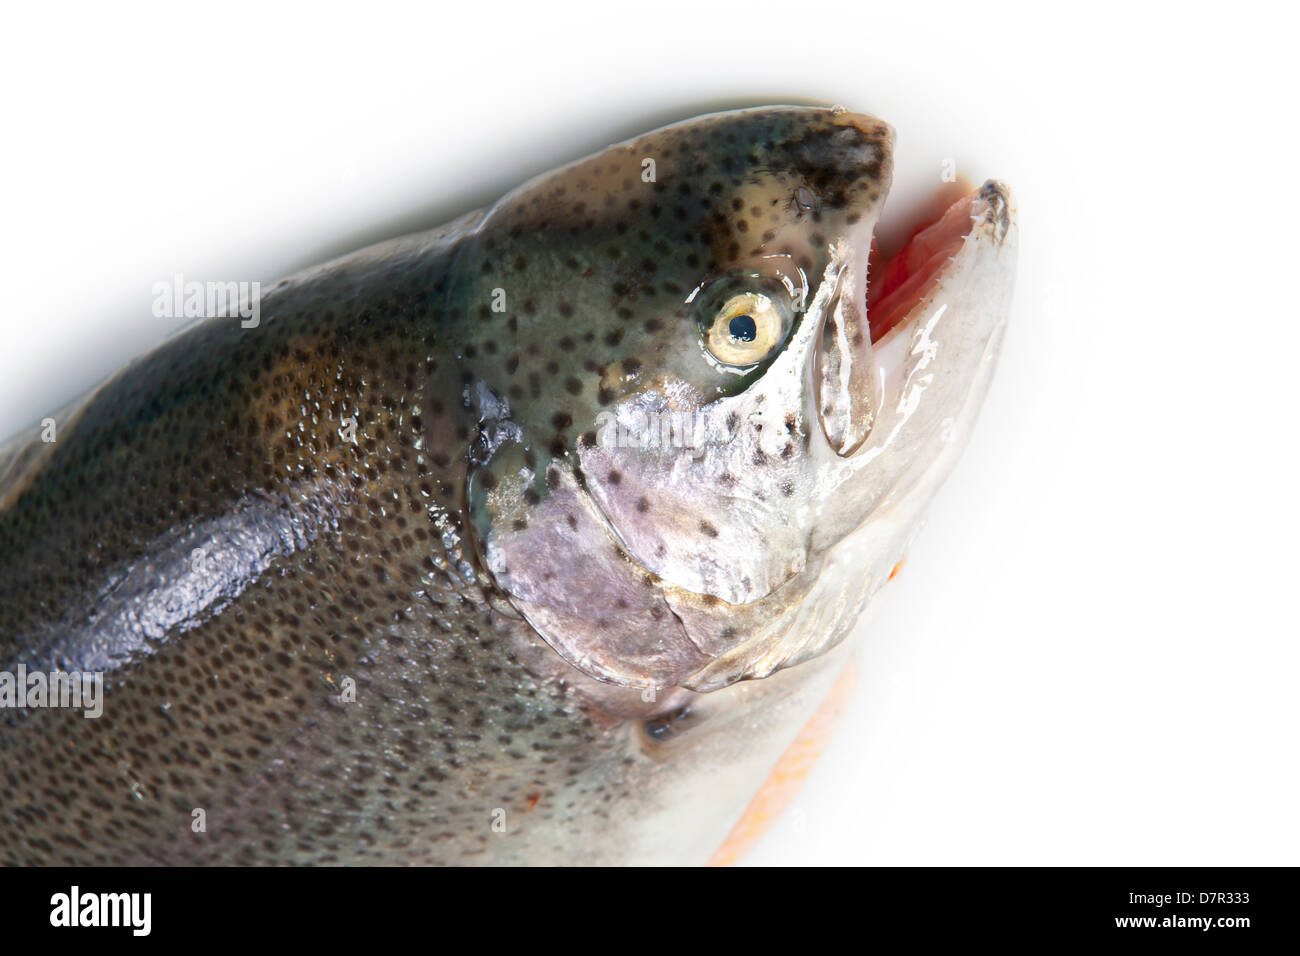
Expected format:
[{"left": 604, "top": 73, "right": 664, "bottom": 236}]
[{"left": 0, "top": 107, "right": 1017, "bottom": 865}]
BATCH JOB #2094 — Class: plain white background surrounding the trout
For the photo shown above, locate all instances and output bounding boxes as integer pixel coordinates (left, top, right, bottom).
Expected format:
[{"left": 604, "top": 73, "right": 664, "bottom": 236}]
[{"left": 0, "top": 0, "right": 1300, "bottom": 864}]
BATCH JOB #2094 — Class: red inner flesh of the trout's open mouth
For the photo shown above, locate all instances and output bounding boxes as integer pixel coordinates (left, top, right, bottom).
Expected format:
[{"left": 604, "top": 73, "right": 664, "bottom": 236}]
[{"left": 867, "top": 177, "right": 978, "bottom": 342}]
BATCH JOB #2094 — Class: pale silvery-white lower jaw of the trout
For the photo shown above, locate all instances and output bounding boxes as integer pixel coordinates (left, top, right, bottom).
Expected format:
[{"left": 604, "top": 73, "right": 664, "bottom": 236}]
[{"left": 696, "top": 181, "right": 1018, "bottom": 691}]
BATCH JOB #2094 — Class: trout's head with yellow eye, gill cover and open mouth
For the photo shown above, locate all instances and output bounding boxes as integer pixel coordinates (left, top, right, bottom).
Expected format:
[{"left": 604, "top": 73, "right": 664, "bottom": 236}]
[{"left": 450, "top": 107, "right": 1015, "bottom": 691}]
